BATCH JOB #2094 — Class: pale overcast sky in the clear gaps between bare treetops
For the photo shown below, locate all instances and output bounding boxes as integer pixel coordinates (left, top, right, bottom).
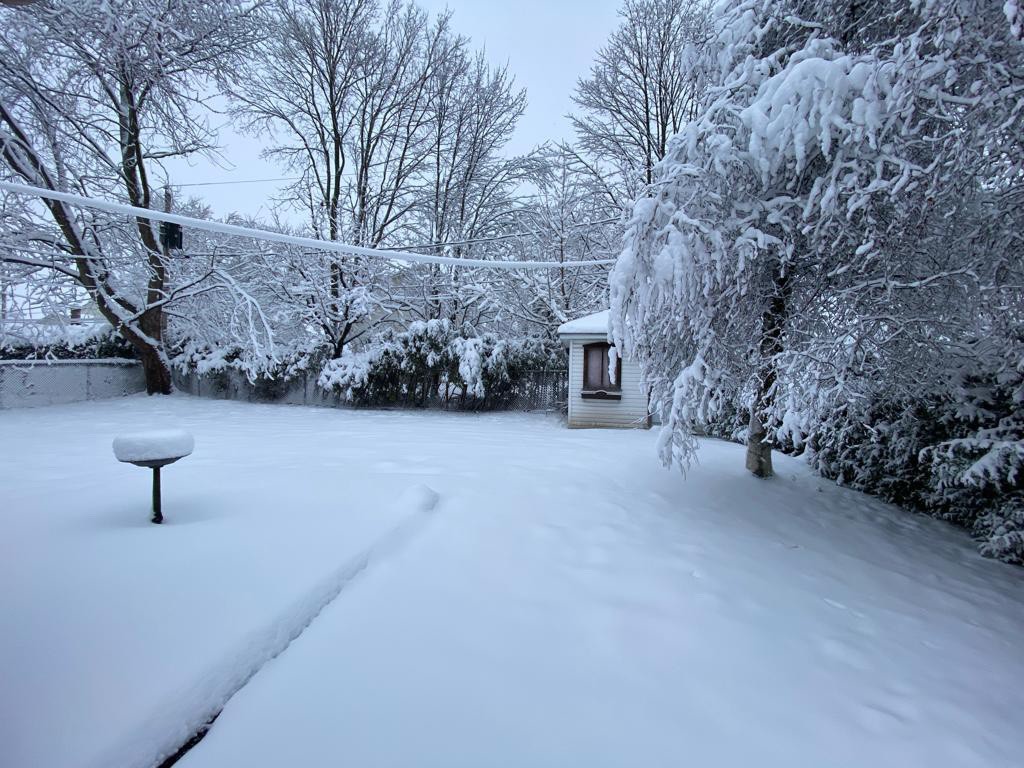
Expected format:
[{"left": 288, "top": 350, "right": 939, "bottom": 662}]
[{"left": 163, "top": 0, "right": 620, "bottom": 222}]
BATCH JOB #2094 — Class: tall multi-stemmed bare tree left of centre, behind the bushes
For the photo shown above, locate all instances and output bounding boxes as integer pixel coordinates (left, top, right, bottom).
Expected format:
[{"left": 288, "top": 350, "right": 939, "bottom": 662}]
[{"left": 229, "top": 0, "right": 458, "bottom": 356}]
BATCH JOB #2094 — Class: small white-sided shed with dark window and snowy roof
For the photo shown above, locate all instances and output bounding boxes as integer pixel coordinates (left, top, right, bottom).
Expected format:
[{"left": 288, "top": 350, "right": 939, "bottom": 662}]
[{"left": 558, "top": 309, "right": 650, "bottom": 428}]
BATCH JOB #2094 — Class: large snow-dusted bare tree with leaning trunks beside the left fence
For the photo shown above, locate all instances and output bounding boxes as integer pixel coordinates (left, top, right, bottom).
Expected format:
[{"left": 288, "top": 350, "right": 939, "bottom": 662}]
[{"left": 0, "top": 0, "right": 260, "bottom": 393}]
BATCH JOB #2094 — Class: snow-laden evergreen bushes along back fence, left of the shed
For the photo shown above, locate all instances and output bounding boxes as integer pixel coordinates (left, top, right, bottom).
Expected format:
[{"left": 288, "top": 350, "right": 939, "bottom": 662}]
[{"left": 319, "top": 319, "right": 560, "bottom": 410}]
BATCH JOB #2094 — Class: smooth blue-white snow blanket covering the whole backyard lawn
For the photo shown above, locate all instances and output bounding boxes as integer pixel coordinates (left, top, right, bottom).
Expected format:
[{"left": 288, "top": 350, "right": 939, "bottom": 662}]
[{"left": 0, "top": 396, "right": 1024, "bottom": 768}]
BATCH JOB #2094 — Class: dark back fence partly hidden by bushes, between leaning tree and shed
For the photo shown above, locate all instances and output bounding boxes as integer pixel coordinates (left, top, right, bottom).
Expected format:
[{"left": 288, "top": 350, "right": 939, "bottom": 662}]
[{"left": 174, "top": 369, "right": 568, "bottom": 413}]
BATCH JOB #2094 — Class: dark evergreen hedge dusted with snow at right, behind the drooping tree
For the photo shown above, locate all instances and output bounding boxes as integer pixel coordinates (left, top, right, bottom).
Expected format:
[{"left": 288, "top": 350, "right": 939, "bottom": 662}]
[{"left": 809, "top": 356, "right": 1024, "bottom": 564}]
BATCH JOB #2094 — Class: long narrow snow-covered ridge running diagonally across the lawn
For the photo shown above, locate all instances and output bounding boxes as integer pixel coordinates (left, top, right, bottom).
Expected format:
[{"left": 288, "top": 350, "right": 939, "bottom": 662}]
[{"left": 93, "top": 484, "right": 439, "bottom": 768}]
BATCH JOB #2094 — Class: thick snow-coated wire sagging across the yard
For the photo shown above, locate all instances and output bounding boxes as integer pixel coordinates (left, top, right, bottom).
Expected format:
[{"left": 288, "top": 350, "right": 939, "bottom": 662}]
[{"left": 0, "top": 181, "right": 614, "bottom": 269}]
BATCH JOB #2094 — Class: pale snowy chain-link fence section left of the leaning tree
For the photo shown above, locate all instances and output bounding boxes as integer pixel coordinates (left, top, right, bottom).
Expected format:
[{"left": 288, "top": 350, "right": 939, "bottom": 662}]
[{"left": 0, "top": 359, "right": 145, "bottom": 409}]
